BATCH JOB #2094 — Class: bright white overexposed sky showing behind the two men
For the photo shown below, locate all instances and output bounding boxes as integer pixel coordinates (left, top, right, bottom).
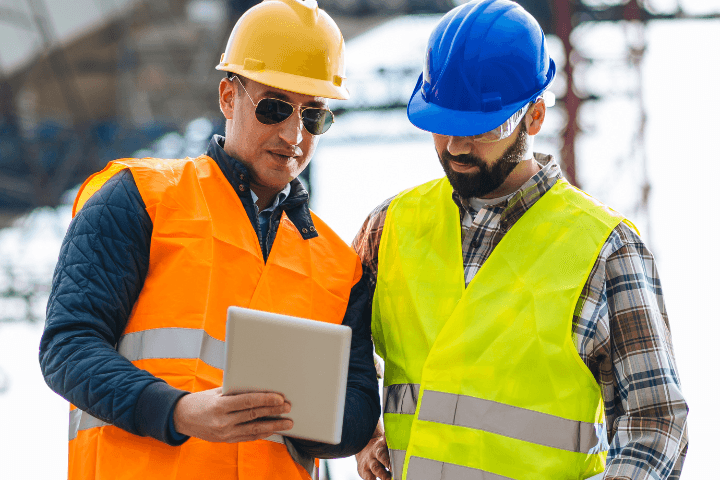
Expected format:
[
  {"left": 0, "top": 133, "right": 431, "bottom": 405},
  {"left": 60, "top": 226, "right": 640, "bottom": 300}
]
[{"left": 0, "top": 4, "right": 720, "bottom": 480}]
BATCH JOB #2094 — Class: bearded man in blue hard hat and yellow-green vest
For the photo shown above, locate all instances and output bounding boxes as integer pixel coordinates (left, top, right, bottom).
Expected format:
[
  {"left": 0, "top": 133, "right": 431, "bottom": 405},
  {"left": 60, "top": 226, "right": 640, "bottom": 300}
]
[{"left": 354, "top": 0, "right": 688, "bottom": 480}]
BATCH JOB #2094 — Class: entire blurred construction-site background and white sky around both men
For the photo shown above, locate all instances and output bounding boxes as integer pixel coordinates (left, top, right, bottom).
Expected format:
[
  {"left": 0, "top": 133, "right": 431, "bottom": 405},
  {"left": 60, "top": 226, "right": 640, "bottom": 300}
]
[{"left": 0, "top": 0, "right": 720, "bottom": 480}]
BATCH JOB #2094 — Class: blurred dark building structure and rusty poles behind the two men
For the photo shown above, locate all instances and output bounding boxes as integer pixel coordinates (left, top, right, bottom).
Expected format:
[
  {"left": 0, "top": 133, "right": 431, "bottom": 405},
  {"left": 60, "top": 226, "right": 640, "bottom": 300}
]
[{"left": 0, "top": 0, "right": 718, "bottom": 228}]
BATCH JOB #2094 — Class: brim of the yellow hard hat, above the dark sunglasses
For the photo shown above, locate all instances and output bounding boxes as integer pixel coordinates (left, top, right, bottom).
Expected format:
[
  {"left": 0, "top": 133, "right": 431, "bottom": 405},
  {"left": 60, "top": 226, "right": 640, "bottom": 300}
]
[{"left": 215, "top": 63, "right": 350, "bottom": 100}]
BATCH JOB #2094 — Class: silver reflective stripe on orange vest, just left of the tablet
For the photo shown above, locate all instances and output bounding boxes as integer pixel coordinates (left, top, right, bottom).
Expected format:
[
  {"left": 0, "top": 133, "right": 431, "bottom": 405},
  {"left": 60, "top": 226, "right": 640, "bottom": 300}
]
[{"left": 118, "top": 328, "right": 225, "bottom": 370}]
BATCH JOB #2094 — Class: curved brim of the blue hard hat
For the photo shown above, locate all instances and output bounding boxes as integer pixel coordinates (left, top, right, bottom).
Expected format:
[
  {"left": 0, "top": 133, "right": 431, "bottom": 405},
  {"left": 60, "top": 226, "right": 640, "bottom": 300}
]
[{"left": 407, "top": 74, "right": 537, "bottom": 137}]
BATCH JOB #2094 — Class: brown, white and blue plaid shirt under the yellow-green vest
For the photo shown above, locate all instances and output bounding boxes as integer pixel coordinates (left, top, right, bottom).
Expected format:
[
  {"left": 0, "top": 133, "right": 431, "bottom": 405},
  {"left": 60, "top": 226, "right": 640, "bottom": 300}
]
[{"left": 353, "top": 154, "right": 688, "bottom": 480}]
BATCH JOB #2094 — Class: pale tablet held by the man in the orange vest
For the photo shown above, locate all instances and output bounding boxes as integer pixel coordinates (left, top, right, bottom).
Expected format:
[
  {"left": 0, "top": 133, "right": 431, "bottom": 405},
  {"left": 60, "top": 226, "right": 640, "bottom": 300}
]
[{"left": 223, "top": 307, "right": 352, "bottom": 444}]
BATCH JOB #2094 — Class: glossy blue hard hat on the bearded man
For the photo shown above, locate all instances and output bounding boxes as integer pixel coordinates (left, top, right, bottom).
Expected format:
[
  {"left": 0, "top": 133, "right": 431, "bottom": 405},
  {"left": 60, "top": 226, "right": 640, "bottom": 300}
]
[{"left": 407, "top": 0, "right": 555, "bottom": 136}]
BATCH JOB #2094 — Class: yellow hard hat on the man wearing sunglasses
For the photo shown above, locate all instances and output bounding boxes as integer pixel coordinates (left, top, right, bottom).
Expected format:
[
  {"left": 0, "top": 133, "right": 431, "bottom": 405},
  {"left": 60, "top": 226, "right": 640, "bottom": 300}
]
[{"left": 215, "top": 0, "right": 350, "bottom": 100}]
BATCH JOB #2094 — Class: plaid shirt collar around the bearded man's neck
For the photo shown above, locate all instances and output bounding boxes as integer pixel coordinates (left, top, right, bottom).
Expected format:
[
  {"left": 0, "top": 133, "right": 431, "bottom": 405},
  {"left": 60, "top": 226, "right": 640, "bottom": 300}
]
[{"left": 452, "top": 153, "right": 562, "bottom": 231}]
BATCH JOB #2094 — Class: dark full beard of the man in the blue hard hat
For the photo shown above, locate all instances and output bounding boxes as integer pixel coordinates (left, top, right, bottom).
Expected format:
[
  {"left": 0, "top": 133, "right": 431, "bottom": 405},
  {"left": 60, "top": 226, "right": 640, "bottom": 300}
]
[{"left": 438, "top": 122, "right": 528, "bottom": 198}]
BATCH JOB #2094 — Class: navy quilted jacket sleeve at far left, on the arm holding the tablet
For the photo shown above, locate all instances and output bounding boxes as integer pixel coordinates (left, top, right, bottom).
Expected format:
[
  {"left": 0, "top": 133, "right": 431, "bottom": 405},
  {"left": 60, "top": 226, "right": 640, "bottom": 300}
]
[{"left": 39, "top": 170, "right": 186, "bottom": 444}]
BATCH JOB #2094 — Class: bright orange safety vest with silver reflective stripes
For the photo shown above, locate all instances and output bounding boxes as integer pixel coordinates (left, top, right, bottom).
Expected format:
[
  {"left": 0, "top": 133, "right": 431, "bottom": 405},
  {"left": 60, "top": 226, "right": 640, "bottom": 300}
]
[{"left": 68, "top": 156, "right": 362, "bottom": 480}]
